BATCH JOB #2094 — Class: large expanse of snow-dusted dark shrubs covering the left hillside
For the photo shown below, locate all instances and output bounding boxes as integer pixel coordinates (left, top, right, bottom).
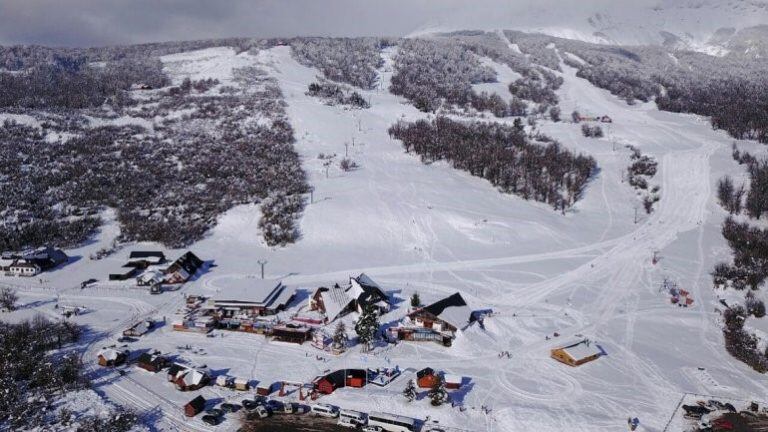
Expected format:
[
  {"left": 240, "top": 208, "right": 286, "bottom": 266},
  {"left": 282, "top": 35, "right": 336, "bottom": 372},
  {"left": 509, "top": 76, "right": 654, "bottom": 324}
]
[{"left": 0, "top": 60, "right": 308, "bottom": 250}]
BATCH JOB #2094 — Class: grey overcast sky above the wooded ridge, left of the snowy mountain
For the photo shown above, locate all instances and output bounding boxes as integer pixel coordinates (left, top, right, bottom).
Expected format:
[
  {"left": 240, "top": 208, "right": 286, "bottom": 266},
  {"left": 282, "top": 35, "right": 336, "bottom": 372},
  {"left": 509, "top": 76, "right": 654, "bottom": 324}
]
[{"left": 0, "top": 0, "right": 476, "bottom": 46}]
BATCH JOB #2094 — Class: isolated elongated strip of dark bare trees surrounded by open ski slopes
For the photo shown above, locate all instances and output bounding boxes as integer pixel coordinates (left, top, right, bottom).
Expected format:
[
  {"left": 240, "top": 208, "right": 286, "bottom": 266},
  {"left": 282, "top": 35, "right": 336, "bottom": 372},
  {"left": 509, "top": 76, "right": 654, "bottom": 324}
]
[{"left": 389, "top": 116, "right": 597, "bottom": 212}]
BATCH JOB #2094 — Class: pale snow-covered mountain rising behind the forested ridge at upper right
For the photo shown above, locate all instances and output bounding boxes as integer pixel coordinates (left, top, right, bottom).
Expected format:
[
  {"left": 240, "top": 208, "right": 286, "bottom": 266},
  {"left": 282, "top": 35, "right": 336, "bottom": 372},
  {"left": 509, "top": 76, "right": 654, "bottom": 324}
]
[{"left": 412, "top": 0, "right": 768, "bottom": 54}]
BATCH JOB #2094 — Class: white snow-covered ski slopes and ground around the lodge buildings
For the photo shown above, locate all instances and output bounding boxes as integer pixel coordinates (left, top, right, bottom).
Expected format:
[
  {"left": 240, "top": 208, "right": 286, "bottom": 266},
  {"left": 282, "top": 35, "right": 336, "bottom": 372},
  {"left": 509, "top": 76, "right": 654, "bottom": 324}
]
[{"left": 2, "top": 41, "right": 768, "bottom": 431}]
